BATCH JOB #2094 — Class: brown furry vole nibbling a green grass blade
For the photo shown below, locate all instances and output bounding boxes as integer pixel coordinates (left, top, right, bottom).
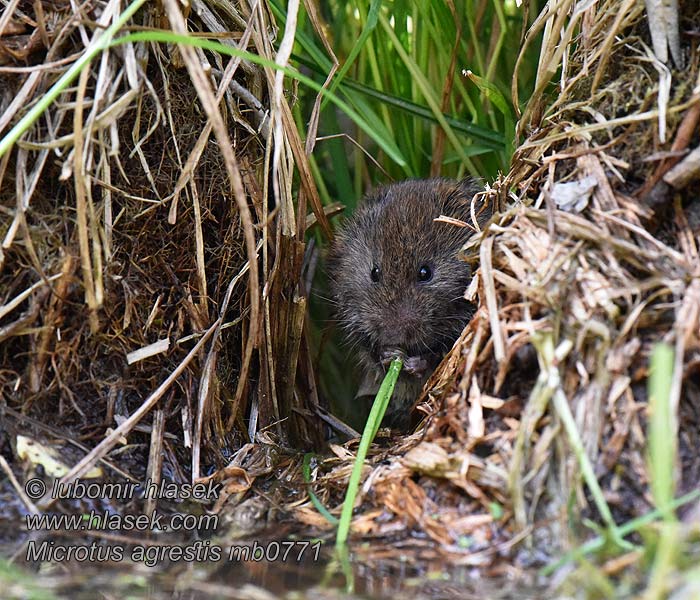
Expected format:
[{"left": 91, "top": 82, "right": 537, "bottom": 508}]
[{"left": 328, "top": 179, "right": 490, "bottom": 428}]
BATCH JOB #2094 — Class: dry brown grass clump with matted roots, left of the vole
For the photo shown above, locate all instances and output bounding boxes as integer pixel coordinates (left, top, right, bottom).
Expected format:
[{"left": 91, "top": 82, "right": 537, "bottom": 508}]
[{"left": 0, "top": 2, "right": 327, "bottom": 500}]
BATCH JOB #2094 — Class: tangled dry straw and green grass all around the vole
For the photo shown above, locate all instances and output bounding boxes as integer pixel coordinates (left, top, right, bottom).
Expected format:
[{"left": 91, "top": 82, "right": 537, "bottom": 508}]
[{"left": 0, "top": 0, "right": 700, "bottom": 598}]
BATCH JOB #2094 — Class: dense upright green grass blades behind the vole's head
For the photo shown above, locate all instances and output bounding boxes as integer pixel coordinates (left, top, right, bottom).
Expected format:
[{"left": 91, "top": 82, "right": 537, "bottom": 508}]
[{"left": 272, "top": 0, "right": 535, "bottom": 204}]
